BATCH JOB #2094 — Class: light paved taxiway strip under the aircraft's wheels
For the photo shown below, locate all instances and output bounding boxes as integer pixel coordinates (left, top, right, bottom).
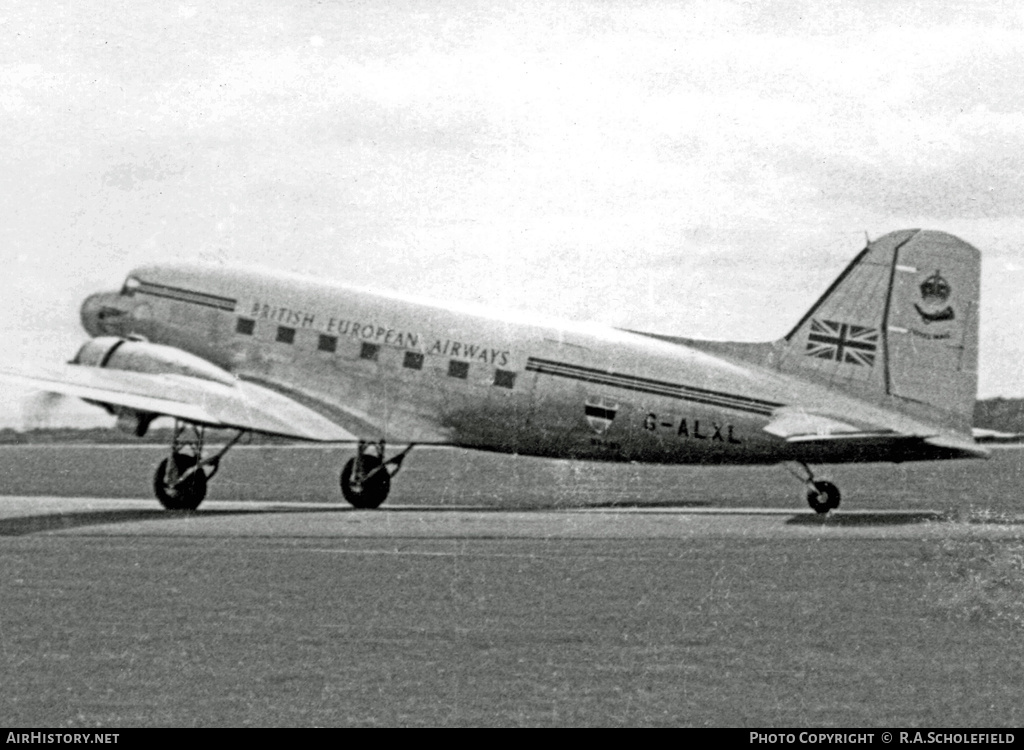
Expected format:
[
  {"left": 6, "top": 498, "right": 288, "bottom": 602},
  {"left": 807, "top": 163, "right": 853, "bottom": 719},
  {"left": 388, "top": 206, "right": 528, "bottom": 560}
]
[{"left": 0, "top": 497, "right": 1024, "bottom": 540}]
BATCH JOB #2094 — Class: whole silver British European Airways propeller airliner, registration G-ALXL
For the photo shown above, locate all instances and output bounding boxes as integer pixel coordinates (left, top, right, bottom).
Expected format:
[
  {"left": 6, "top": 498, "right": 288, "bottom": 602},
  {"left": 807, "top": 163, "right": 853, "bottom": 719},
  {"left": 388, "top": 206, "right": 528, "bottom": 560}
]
[{"left": 4, "top": 230, "right": 987, "bottom": 513}]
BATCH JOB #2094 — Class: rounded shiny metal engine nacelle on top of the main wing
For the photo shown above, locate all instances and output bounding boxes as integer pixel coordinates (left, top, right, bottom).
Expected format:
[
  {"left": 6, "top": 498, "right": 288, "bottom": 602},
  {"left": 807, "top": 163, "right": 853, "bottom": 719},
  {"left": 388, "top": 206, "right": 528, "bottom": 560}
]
[{"left": 71, "top": 336, "right": 234, "bottom": 385}]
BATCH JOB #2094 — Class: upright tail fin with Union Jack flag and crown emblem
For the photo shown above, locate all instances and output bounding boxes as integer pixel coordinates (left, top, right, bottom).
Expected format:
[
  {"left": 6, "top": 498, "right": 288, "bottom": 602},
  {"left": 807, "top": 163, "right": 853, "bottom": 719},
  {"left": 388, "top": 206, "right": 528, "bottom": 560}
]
[{"left": 778, "top": 230, "right": 981, "bottom": 432}]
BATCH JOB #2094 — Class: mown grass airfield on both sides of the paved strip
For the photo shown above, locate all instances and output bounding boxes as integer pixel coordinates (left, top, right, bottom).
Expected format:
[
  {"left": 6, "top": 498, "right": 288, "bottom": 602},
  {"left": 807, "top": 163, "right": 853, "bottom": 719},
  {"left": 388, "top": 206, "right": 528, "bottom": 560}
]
[{"left": 0, "top": 448, "right": 1024, "bottom": 727}]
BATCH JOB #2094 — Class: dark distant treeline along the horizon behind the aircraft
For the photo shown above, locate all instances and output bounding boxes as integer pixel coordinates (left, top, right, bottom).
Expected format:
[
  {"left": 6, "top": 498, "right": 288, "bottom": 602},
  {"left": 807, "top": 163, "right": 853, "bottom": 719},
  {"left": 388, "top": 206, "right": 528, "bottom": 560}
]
[{"left": 0, "top": 399, "right": 1024, "bottom": 446}]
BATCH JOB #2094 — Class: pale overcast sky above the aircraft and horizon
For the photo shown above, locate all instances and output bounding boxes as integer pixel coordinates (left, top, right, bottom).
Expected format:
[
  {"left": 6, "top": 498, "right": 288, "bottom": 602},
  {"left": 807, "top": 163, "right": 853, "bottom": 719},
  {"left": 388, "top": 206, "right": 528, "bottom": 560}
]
[{"left": 0, "top": 0, "right": 1024, "bottom": 424}]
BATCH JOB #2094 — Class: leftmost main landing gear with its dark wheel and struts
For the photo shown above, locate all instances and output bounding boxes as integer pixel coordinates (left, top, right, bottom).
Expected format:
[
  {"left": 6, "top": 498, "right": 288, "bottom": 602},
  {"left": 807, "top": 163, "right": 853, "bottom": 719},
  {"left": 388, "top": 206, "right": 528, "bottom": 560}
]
[{"left": 153, "top": 420, "right": 245, "bottom": 510}]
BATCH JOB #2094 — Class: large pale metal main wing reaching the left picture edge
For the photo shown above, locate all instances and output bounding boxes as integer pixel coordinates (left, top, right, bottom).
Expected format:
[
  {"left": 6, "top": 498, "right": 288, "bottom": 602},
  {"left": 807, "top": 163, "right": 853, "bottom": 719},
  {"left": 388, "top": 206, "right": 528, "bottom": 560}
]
[{"left": 0, "top": 365, "right": 356, "bottom": 443}]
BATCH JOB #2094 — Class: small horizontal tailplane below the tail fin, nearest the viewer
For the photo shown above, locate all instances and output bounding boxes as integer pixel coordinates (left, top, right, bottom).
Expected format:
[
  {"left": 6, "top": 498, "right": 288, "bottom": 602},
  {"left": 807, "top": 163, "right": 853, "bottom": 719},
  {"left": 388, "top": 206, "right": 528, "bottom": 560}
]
[{"left": 764, "top": 409, "right": 988, "bottom": 458}]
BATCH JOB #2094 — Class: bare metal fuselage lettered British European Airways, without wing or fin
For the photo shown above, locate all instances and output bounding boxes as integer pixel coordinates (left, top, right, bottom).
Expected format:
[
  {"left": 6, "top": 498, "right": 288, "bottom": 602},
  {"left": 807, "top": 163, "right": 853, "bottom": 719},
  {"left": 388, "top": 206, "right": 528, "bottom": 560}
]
[{"left": 83, "top": 265, "right": 962, "bottom": 463}]
